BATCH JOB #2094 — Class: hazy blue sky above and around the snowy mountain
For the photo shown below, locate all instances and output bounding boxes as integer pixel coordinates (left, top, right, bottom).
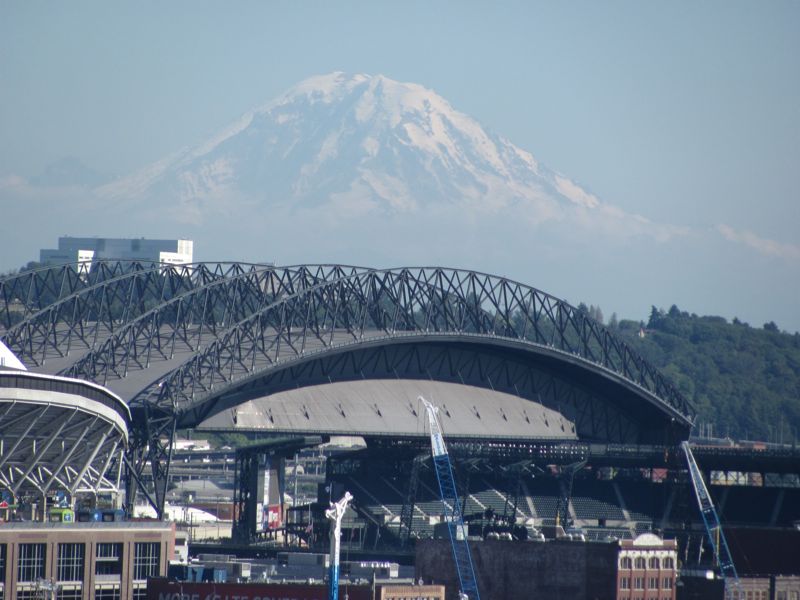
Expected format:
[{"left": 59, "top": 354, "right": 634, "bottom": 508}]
[{"left": 0, "top": 0, "right": 800, "bottom": 330}]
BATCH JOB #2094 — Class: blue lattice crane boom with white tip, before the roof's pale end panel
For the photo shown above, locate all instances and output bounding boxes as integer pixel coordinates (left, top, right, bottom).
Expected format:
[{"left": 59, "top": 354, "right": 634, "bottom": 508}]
[{"left": 419, "top": 396, "right": 480, "bottom": 600}]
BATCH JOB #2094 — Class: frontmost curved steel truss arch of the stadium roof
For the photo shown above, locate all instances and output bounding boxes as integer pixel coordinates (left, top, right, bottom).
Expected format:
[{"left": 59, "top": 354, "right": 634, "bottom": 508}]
[{"left": 138, "top": 267, "right": 694, "bottom": 424}]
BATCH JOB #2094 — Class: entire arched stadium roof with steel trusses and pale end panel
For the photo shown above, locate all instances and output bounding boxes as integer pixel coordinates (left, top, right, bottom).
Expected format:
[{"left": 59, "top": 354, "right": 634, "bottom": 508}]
[{"left": 0, "top": 262, "right": 694, "bottom": 442}]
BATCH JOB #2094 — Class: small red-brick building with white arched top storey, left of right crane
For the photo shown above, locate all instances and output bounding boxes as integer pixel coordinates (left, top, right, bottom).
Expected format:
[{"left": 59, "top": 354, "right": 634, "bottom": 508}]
[{"left": 617, "top": 533, "right": 678, "bottom": 600}]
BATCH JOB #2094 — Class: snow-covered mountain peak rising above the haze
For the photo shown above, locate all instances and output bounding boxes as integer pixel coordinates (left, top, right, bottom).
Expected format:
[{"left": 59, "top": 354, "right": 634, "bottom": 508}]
[{"left": 97, "top": 72, "right": 612, "bottom": 223}]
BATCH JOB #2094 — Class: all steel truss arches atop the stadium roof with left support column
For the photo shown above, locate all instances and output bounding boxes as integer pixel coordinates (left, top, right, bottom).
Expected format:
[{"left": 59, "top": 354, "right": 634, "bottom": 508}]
[{"left": 0, "top": 262, "right": 694, "bottom": 516}]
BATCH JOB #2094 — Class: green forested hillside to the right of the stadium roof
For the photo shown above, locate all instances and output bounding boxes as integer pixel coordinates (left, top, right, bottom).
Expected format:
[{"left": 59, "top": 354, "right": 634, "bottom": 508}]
[{"left": 608, "top": 305, "right": 800, "bottom": 444}]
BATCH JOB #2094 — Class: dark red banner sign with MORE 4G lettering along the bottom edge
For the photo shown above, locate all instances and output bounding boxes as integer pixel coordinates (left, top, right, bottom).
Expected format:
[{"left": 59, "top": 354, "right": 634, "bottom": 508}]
[{"left": 147, "top": 579, "right": 372, "bottom": 600}]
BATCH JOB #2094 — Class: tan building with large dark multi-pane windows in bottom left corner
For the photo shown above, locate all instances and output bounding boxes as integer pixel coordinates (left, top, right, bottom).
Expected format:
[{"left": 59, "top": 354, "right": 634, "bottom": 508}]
[{"left": 0, "top": 522, "right": 175, "bottom": 600}]
